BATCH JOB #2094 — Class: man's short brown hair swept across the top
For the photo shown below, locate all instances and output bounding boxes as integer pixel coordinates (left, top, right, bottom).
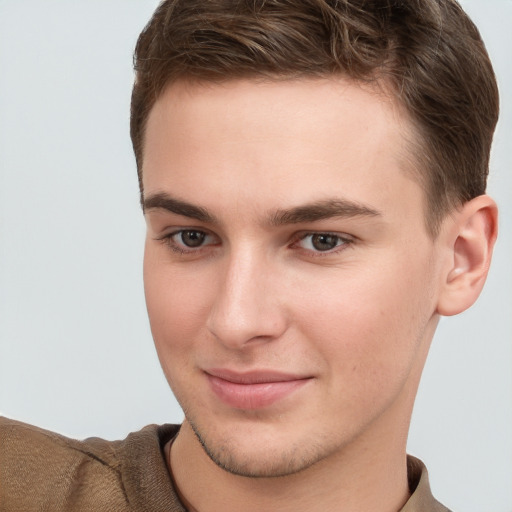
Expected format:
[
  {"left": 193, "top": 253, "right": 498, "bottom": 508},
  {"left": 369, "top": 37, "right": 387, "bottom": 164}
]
[{"left": 131, "top": 0, "right": 499, "bottom": 235}]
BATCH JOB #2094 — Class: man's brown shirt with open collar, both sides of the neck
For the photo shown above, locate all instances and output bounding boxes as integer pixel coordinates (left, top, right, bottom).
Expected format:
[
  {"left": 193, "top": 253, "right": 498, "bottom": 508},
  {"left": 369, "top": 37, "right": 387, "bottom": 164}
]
[{"left": 0, "top": 417, "right": 449, "bottom": 512}]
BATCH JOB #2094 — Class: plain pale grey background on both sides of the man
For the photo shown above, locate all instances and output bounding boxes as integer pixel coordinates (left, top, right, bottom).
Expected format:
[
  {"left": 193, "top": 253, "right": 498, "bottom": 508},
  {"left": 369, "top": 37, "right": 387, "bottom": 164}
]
[{"left": 0, "top": 0, "right": 512, "bottom": 512}]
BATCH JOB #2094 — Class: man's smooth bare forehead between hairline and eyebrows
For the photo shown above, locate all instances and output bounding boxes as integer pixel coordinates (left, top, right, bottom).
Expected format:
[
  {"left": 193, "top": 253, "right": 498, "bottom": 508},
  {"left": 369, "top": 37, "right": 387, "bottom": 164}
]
[{"left": 142, "top": 78, "right": 423, "bottom": 224}]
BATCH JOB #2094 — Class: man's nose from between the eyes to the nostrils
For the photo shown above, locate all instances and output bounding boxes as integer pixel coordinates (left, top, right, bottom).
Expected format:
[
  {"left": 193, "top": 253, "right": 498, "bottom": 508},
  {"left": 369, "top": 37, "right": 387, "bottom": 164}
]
[{"left": 207, "top": 247, "right": 287, "bottom": 349}]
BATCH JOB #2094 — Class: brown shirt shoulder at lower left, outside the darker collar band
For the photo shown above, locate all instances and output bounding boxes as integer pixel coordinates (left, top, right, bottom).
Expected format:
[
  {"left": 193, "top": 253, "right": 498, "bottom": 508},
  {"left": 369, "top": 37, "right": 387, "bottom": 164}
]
[{"left": 0, "top": 418, "right": 126, "bottom": 511}]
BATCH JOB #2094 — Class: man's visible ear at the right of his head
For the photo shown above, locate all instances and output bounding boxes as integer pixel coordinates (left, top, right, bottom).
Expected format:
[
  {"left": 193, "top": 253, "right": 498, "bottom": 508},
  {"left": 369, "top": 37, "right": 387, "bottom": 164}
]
[{"left": 437, "top": 195, "right": 498, "bottom": 316}]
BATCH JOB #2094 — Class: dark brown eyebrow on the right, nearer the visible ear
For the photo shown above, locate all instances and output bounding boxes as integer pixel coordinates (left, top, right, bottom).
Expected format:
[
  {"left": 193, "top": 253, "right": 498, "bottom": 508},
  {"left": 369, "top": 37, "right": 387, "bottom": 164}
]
[{"left": 269, "top": 198, "right": 382, "bottom": 226}]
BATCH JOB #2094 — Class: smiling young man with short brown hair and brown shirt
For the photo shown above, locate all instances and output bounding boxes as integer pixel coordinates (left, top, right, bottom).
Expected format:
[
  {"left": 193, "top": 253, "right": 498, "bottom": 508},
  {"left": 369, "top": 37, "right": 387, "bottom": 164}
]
[{"left": 0, "top": 0, "right": 498, "bottom": 512}]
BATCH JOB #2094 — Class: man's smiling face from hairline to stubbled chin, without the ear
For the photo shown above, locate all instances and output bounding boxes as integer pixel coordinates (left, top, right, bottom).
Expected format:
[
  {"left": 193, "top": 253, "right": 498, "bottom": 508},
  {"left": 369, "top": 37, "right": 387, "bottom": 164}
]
[{"left": 143, "top": 78, "right": 438, "bottom": 476}]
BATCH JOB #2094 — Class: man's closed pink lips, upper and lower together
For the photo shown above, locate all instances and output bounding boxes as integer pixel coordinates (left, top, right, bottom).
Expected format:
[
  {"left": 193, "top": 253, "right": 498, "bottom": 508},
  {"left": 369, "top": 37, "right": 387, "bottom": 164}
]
[{"left": 205, "top": 368, "right": 312, "bottom": 410}]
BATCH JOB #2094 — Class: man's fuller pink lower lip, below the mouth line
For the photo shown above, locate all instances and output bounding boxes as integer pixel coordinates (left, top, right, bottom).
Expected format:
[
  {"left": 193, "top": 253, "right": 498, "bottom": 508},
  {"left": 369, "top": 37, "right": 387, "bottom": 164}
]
[{"left": 207, "top": 375, "right": 311, "bottom": 409}]
